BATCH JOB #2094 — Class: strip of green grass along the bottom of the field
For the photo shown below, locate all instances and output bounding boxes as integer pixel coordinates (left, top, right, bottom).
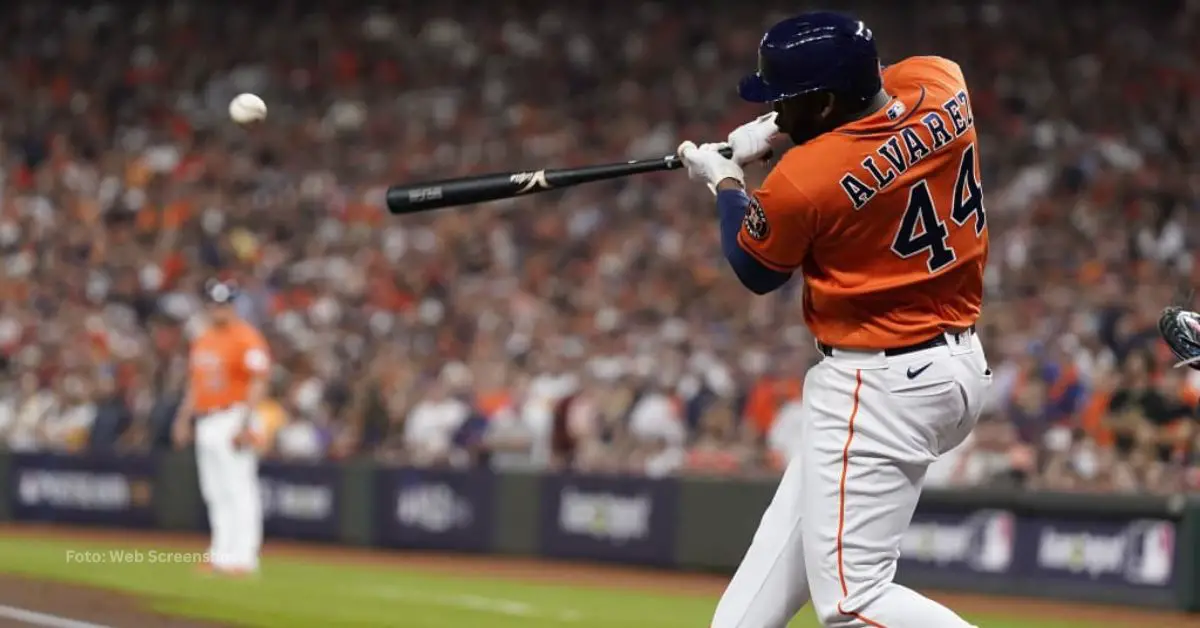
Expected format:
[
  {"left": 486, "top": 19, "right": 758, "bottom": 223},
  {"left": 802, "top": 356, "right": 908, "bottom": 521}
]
[{"left": 0, "top": 537, "right": 1123, "bottom": 628}]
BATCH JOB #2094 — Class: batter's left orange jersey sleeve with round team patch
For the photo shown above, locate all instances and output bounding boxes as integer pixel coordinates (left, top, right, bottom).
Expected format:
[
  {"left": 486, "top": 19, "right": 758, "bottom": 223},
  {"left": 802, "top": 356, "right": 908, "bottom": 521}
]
[{"left": 738, "top": 164, "right": 816, "bottom": 273}]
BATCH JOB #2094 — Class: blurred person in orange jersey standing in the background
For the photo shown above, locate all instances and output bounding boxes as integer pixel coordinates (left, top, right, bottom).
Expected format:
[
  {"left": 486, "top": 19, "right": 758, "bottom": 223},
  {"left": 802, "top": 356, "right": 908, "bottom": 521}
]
[{"left": 173, "top": 281, "right": 270, "bottom": 575}]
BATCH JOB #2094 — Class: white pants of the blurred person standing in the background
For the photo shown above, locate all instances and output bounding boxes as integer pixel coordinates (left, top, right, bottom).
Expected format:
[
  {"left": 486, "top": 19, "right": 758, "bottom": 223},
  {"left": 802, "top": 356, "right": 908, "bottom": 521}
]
[{"left": 196, "top": 406, "right": 263, "bottom": 570}]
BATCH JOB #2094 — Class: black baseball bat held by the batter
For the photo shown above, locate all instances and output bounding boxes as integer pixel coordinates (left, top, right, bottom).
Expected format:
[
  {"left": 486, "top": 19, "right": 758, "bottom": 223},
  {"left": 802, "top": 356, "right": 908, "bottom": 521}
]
[{"left": 388, "top": 146, "right": 733, "bottom": 214}]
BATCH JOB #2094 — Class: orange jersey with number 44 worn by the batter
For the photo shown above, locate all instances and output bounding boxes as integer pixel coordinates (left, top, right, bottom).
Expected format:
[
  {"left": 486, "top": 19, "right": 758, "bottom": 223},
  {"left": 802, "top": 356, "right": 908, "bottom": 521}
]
[{"left": 738, "top": 56, "right": 988, "bottom": 349}]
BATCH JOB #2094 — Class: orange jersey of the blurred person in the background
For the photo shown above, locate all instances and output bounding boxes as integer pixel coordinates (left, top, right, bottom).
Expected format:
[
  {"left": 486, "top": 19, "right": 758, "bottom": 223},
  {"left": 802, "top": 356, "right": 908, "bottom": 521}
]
[{"left": 188, "top": 321, "right": 270, "bottom": 414}]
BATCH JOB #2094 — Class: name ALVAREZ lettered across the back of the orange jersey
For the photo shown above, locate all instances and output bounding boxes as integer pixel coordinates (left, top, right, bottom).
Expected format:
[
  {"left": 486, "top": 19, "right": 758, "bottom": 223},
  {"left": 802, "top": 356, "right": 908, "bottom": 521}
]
[{"left": 840, "top": 91, "right": 974, "bottom": 210}]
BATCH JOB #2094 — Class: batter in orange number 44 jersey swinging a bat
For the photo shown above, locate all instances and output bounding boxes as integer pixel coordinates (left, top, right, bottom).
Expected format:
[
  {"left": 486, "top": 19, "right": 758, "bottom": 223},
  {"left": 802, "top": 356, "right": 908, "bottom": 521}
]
[{"left": 679, "top": 12, "right": 991, "bottom": 628}]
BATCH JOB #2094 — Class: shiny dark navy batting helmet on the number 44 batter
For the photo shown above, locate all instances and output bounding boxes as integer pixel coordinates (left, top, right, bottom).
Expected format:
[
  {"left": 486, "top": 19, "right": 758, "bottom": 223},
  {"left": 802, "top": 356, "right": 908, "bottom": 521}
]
[{"left": 738, "top": 11, "right": 883, "bottom": 104}]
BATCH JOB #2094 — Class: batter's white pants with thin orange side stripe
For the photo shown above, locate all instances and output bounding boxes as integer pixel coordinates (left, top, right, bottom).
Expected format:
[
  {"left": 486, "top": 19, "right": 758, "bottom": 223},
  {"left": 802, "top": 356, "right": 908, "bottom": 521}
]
[{"left": 712, "top": 334, "right": 991, "bottom": 628}]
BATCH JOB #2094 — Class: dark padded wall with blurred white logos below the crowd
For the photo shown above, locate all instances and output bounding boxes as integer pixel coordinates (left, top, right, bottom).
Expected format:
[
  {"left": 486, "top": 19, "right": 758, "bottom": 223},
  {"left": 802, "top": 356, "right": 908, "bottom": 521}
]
[{"left": 0, "top": 451, "right": 1200, "bottom": 611}]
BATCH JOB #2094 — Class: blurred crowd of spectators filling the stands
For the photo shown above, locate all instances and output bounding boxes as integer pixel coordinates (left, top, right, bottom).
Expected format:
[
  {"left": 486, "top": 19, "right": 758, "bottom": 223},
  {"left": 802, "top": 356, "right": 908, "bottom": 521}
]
[{"left": 0, "top": 0, "right": 1200, "bottom": 492}]
